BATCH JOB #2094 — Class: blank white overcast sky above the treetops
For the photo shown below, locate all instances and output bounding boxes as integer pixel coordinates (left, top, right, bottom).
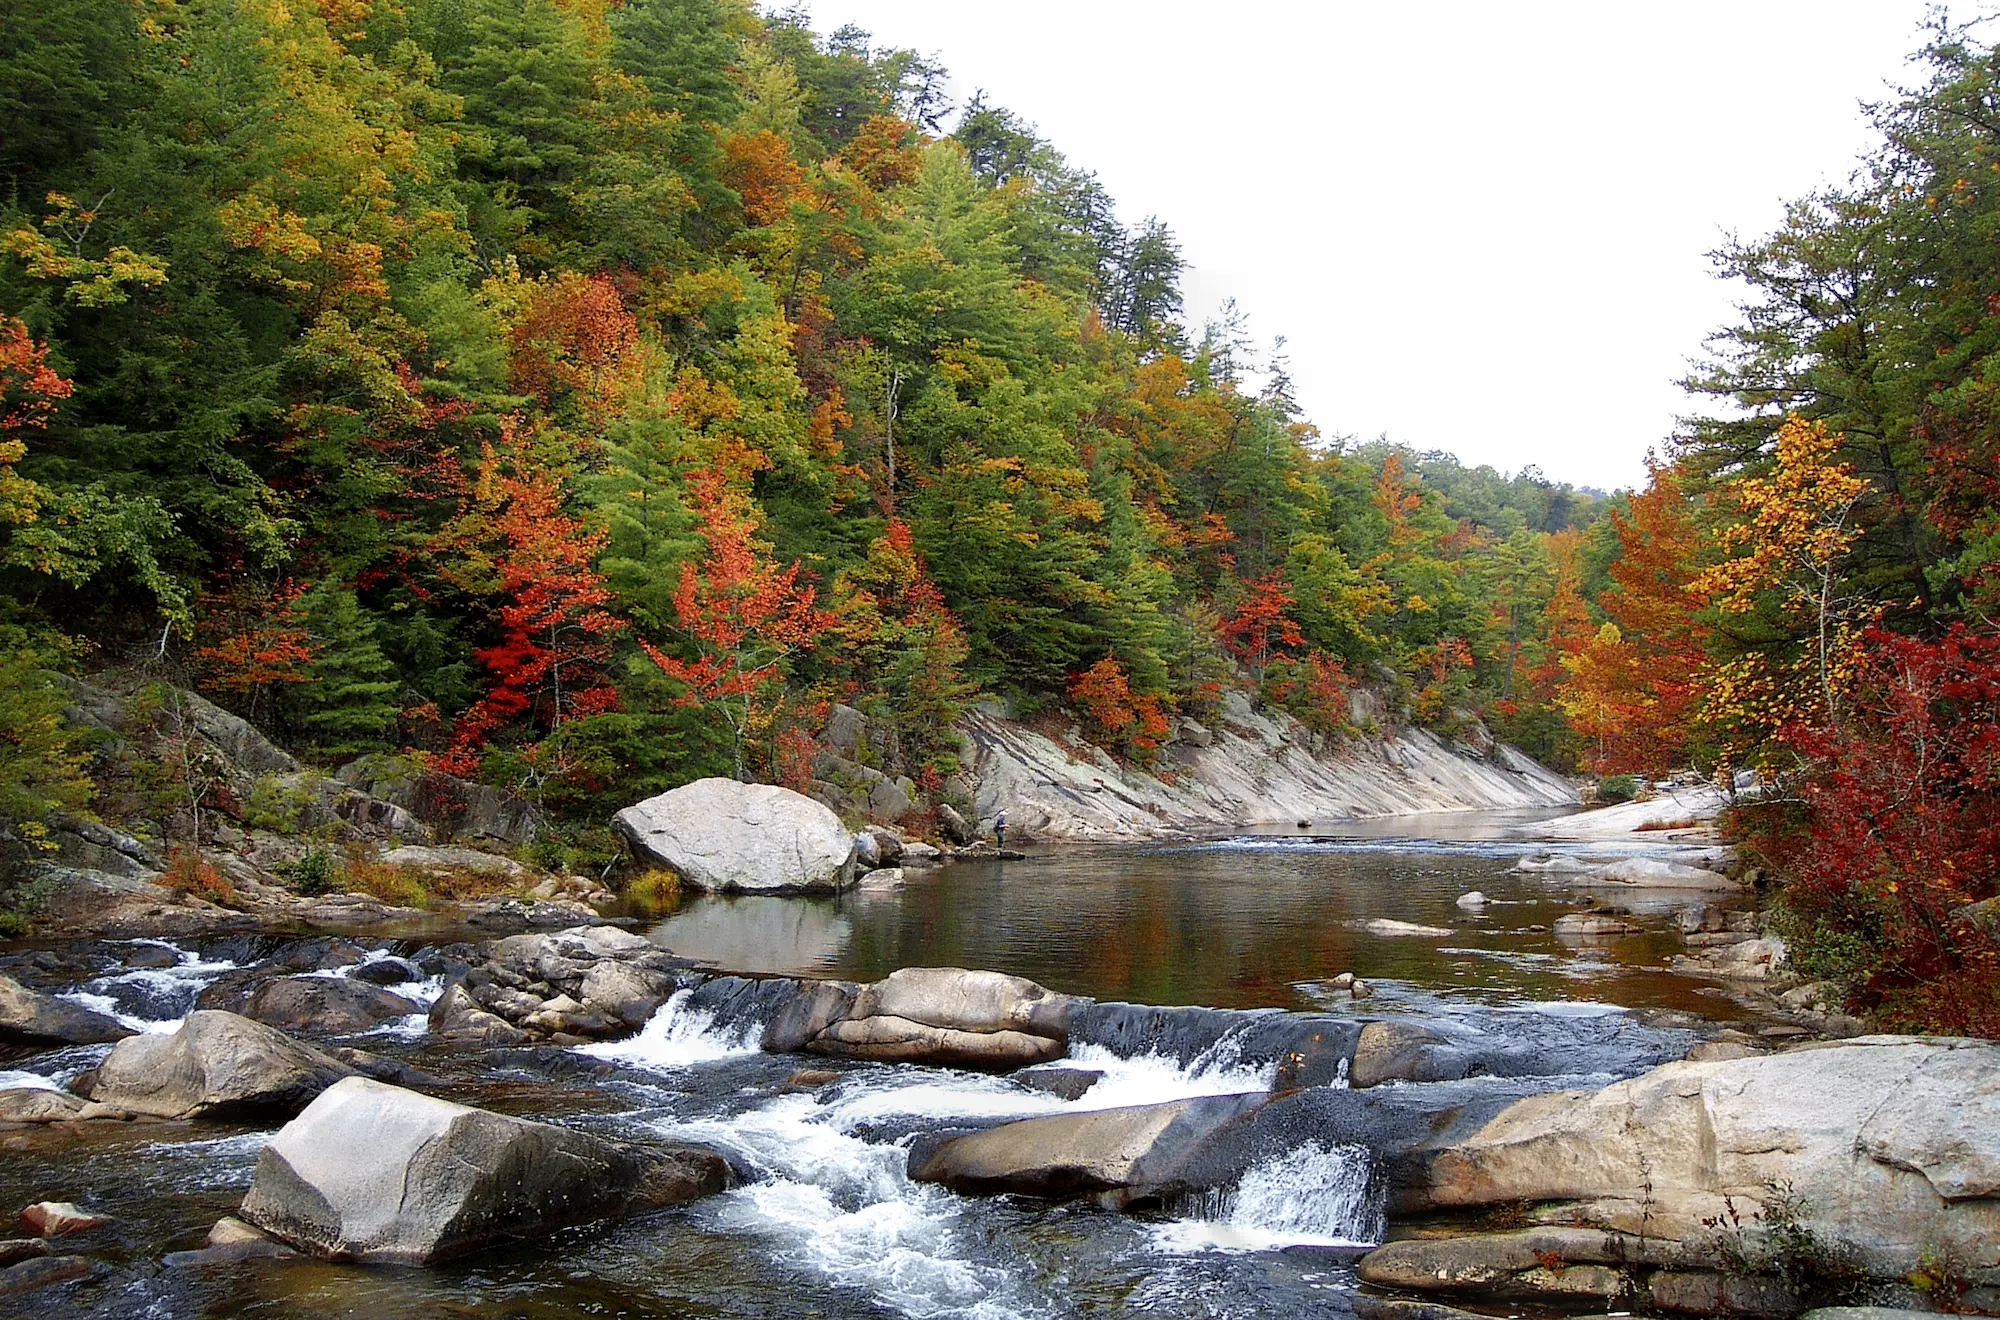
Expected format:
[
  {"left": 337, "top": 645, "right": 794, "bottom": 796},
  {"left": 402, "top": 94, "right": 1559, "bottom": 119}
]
[{"left": 810, "top": 0, "right": 1952, "bottom": 486}]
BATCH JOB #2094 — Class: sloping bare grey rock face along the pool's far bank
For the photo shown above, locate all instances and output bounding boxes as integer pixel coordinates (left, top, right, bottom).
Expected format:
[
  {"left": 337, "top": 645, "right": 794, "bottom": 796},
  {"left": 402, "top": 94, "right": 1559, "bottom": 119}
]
[{"left": 960, "top": 694, "right": 1576, "bottom": 840}]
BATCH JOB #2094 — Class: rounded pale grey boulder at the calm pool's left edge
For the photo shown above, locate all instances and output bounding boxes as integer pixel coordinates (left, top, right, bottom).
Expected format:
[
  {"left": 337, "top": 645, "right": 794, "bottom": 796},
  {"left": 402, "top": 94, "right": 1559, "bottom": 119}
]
[{"left": 612, "top": 778, "right": 854, "bottom": 894}]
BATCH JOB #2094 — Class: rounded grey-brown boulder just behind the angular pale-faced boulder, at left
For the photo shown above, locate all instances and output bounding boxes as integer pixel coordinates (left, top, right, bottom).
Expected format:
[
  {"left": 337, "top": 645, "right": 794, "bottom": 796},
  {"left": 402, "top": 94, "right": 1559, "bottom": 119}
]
[{"left": 74, "top": 1010, "right": 354, "bottom": 1118}]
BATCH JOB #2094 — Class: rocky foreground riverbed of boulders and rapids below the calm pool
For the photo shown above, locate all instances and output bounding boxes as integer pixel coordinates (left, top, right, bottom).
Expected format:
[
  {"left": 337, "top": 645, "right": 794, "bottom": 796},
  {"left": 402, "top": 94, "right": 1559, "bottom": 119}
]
[{"left": 0, "top": 880, "right": 2000, "bottom": 1320}]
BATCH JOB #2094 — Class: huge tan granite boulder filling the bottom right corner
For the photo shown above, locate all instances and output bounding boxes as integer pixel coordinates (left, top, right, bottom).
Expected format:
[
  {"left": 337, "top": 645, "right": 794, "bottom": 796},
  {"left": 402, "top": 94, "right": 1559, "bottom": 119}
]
[{"left": 1390, "top": 1036, "right": 2000, "bottom": 1276}]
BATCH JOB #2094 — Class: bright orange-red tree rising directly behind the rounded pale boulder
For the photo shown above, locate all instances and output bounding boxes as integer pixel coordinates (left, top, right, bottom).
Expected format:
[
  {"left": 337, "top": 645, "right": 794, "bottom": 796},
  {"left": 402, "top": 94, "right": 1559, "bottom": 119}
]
[{"left": 640, "top": 468, "right": 832, "bottom": 778}]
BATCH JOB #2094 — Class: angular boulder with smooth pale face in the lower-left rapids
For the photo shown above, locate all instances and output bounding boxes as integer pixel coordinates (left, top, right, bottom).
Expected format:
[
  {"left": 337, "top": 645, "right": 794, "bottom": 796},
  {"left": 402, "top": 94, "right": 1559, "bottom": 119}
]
[{"left": 238, "top": 1078, "right": 728, "bottom": 1264}]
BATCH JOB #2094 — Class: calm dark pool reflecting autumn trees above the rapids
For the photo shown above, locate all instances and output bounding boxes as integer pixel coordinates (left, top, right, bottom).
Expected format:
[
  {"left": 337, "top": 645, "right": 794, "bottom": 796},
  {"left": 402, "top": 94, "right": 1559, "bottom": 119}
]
[{"left": 652, "top": 816, "right": 1734, "bottom": 1016}]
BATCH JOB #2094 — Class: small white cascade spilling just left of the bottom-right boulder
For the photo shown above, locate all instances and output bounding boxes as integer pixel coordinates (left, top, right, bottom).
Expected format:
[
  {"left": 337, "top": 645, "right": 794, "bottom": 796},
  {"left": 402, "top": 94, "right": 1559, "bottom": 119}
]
[{"left": 1154, "top": 1142, "right": 1386, "bottom": 1254}]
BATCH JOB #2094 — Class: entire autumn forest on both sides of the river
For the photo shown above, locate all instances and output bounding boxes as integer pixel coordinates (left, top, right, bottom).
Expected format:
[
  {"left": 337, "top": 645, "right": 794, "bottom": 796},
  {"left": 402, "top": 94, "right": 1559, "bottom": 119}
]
[{"left": 0, "top": 0, "right": 2000, "bottom": 1034}]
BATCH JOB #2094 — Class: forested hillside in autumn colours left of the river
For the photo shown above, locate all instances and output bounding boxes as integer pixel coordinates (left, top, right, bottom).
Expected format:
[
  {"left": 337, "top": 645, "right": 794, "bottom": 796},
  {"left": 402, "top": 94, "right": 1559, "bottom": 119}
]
[{"left": 0, "top": 0, "right": 1606, "bottom": 816}]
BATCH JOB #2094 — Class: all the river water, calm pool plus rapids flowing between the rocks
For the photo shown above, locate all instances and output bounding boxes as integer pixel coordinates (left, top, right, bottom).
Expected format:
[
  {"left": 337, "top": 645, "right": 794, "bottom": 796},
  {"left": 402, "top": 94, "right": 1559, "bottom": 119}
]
[{"left": 0, "top": 826, "right": 1730, "bottom": 1320}]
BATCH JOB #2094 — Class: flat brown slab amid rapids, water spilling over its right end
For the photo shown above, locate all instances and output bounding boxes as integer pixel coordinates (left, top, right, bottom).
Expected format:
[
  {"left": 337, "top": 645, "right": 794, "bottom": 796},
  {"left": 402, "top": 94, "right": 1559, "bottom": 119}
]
[{"left": 910, "top": 1094, "right": 1270, "bottom": 1204}]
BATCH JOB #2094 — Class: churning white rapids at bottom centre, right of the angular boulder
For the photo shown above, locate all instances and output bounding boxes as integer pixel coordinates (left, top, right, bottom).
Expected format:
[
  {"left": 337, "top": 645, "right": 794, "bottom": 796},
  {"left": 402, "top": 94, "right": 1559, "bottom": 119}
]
[{"left": 664, "top": 1070, "right": 1052, "bottom": 1320}]
